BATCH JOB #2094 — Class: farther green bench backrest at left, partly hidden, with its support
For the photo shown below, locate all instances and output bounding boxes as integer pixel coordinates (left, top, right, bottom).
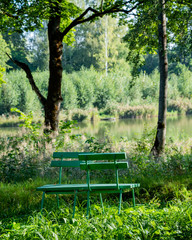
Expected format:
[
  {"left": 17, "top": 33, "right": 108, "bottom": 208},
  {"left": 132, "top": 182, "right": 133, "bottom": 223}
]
[{"left": 51, "top": 152, "right": 91, "bottom": 184}]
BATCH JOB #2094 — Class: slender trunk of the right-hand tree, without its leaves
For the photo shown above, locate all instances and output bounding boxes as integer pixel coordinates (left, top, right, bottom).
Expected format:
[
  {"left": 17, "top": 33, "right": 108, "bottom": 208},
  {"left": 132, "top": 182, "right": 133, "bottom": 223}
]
[{"left": 151, "top": 0, "right": 168, "bottom": 156}]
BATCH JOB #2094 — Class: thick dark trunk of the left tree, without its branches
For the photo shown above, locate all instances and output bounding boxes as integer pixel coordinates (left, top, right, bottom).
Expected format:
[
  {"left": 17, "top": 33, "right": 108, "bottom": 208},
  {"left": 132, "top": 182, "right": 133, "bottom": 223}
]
[{"left": 44, "top": 17, "right": 63, "bottom": 131}]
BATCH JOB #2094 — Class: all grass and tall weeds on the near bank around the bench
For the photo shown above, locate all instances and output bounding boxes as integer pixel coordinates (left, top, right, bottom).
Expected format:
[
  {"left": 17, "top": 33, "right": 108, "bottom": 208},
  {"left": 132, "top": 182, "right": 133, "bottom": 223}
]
[{"left": 0, "top": 119, "right": 192, "bottom": 240}]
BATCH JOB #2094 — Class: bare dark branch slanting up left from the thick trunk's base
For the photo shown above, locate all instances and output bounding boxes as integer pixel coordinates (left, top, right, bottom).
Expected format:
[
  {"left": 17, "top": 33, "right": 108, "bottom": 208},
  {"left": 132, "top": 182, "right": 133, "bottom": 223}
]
[{"left": 6, "top": 53, "right": 47, "bottom": 106}]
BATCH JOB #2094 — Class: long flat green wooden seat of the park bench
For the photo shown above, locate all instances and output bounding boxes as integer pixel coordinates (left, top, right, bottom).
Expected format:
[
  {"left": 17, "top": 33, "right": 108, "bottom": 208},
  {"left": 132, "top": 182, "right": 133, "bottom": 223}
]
[{"left": 37, "top": 183, "right": 140, "bottom": 193}]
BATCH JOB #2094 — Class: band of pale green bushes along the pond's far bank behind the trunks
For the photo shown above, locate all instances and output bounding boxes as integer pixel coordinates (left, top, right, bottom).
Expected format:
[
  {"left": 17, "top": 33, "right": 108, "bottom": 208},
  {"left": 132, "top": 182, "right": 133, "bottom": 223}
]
[{"left": 0, "top": 62, "right": 192, "bottom": 116}]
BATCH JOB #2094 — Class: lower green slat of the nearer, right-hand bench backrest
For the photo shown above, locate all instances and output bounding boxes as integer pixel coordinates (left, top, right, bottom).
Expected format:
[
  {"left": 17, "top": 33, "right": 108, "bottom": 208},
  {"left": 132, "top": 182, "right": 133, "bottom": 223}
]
[{"left": 80, "top": 162, "right": 128, "bottom": 170}]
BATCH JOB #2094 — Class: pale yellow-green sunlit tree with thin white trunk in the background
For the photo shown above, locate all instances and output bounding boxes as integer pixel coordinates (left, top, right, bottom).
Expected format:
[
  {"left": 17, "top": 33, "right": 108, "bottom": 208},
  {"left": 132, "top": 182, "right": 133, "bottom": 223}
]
[{"left": 87, "top": 16, "right": 127, "bottom": 75}]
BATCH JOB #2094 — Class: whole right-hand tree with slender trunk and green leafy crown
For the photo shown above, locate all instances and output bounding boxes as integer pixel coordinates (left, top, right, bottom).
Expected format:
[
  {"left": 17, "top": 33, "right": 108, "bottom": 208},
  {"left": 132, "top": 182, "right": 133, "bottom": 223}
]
[{"left": 125, "top": 0, "right": 192, "bottom": 156}]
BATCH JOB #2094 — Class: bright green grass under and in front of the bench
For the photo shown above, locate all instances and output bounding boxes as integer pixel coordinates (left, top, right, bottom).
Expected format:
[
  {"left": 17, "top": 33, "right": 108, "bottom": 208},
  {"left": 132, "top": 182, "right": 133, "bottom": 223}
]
[{"left": 0, "top": 180, "right": 192, "bottom": 240}]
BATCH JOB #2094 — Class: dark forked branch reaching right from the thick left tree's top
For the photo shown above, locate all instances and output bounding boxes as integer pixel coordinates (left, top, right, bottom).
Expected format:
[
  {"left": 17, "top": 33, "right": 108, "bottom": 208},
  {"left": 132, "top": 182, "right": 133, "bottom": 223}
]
[{"left": 61, "top": 1, "right": 144, "bottom": 37}]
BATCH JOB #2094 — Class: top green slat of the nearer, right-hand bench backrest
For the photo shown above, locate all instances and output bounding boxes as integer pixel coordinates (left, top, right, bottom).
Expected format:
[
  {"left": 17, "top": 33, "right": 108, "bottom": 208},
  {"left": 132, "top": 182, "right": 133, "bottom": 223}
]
[{"left": 79, "top": 153, "right": 126, "bottom": 161}]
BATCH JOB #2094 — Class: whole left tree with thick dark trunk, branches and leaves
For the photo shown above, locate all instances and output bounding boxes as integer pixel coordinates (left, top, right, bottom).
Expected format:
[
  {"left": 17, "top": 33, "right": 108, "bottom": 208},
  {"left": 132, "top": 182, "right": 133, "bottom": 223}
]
[{"left": 0, "top": 0, "right": 144, "bottom": 131}]
